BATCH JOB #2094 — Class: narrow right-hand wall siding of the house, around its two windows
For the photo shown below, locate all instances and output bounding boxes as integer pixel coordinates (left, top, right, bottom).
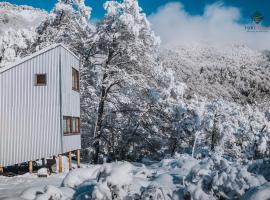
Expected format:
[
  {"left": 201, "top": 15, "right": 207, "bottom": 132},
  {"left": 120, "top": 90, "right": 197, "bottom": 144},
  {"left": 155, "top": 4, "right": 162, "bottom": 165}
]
[{"left": 61, "top": 48, "right": 81, "bottom": 153}]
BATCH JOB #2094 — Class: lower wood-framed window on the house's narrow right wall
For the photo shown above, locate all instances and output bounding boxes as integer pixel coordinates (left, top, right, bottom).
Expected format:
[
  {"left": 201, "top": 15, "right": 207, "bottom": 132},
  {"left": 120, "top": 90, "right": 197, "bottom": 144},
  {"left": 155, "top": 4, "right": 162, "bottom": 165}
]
[{"left": 63, "top": 116, "right": 80, "bottom": 136}]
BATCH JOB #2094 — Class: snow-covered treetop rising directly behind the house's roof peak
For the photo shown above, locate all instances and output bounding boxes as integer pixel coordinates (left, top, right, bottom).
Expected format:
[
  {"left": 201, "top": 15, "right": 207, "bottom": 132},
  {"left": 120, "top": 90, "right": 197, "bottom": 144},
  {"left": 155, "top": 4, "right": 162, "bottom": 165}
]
[{"left": 27, "top": 0, "right": 94, "bottom": 56}]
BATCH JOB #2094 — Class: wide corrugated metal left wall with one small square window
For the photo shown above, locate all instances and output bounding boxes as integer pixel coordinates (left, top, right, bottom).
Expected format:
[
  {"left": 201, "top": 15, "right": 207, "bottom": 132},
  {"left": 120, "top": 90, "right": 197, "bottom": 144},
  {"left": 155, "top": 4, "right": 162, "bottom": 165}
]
[{"left": 0, "top": 46, "right": 61, "bottom": 166}]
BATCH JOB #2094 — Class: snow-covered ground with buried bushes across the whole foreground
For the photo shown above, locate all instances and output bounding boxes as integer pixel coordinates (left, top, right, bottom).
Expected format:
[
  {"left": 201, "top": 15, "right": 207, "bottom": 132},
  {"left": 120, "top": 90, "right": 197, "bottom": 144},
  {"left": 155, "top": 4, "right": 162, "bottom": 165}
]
[{"left": 0, "top": 155, "right": 270, "bottom": 200}]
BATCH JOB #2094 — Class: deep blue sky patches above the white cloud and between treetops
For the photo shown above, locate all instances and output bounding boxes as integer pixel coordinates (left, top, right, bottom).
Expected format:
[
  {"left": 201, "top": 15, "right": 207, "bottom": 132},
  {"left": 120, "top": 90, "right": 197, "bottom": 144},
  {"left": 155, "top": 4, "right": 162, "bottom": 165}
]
[{"left": 3, "top": 0, "right": 270, "bottom": 25}]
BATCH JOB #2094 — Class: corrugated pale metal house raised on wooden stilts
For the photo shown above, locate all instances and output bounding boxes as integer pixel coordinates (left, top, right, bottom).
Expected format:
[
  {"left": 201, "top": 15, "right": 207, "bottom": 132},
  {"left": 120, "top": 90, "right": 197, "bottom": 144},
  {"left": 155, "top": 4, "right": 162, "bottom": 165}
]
[{"left": 0, "top": 44, "right": 81, "bottom": 168}]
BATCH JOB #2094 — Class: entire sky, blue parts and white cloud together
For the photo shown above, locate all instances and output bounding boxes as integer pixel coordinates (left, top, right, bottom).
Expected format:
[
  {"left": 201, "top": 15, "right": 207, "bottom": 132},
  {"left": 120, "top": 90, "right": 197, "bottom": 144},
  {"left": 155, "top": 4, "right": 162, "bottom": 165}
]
[{"left": 3, "top": 0, "right": 270, "bottom": 50}]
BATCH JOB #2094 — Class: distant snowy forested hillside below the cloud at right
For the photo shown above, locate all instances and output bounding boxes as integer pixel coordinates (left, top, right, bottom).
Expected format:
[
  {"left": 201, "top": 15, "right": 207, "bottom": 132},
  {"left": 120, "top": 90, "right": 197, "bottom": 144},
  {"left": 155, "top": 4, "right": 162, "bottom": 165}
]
[{"left": 161, "top": 45, "right": 270, "bottom": 108}]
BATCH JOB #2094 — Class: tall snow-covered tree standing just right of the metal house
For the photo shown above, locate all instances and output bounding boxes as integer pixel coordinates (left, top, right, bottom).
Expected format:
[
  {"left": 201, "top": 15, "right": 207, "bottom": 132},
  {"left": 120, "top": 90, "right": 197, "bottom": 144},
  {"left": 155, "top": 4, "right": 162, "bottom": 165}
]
[{"left": 86, "top": 0, "right": 186, "bottom": 162}]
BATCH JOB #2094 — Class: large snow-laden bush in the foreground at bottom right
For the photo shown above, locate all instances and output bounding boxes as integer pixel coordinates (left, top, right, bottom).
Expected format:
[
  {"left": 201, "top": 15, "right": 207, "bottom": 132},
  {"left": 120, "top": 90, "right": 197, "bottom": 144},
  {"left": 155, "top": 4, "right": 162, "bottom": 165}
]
[{"left": 185, "top": 156, "right": 266, "bottom": 200}]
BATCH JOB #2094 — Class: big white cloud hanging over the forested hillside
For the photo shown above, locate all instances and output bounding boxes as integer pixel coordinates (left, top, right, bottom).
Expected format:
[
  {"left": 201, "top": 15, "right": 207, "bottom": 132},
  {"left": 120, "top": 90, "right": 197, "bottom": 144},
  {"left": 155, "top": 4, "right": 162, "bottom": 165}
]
[{"left": 149, "top": 2, "right": 270, "bottom": 49}]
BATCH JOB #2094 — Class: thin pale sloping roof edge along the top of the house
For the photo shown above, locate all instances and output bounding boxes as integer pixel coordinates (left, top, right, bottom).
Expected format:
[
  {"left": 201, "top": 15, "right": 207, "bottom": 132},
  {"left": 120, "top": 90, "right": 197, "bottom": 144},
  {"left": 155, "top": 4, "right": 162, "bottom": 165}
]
[{"left": 0, "top": 43, "right": 79, "bottom": 73}]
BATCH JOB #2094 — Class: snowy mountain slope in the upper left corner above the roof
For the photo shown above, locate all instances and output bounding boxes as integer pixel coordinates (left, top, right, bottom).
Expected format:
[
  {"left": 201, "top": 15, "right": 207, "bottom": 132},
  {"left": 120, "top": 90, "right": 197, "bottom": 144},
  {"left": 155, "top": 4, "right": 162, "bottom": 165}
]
[{"left": 0, "top": 2, "right": 48, "bottom": 67}]
